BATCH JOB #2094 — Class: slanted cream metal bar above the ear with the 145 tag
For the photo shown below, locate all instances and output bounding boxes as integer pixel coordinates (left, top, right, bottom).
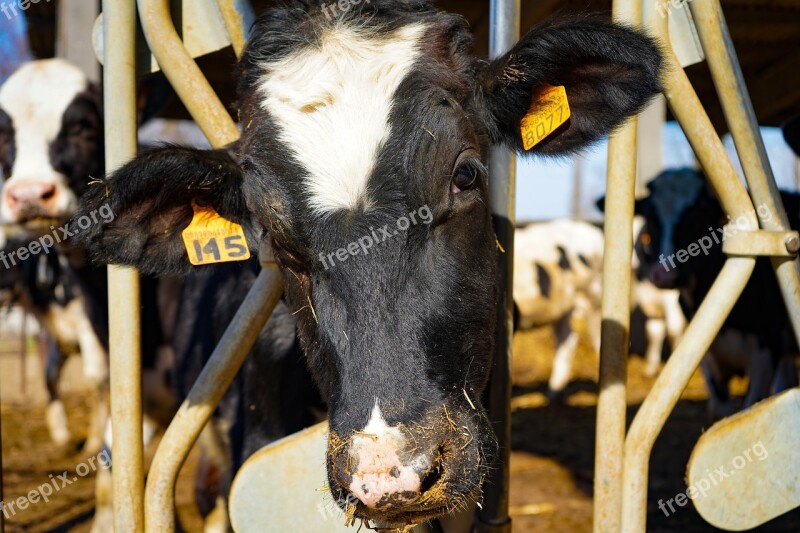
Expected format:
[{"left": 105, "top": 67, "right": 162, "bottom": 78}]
[{"left": 138, "top": 0, "right": 239, "bottom": 147}]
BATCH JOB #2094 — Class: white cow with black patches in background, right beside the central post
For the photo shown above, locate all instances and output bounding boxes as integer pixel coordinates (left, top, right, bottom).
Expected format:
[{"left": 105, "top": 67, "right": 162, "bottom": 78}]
[{"left": 514, "top": 220, "right": 603, "bottom": 400}]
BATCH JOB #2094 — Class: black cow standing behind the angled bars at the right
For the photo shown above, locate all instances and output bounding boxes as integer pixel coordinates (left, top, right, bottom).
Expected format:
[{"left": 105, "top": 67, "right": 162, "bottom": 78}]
[{"left": 636, "top": 169, "right": 800, "bottom": 421}]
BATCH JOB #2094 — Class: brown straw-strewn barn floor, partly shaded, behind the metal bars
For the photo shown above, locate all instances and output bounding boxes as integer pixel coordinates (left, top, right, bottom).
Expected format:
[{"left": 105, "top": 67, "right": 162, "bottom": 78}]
[{"left": 0, "top": 330, "right": 800, "bottom": 533}]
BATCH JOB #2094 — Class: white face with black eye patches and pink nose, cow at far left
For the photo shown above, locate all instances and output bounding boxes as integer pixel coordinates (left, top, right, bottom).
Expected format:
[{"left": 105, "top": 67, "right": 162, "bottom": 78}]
[{"left": 0, "top": 60, "right": 103, "bottom": 229}]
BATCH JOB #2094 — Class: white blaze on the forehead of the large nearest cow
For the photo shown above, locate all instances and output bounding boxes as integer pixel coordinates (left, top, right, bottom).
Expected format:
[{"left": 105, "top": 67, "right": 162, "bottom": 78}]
[{"left": 260, "top": 24, "right": 426, "bottom": 216}]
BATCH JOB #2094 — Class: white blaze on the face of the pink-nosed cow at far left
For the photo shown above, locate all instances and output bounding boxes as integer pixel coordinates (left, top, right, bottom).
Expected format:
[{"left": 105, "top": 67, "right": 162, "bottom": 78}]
[{"left": 0, "top": 59, "right": 89, "bottom": 218}]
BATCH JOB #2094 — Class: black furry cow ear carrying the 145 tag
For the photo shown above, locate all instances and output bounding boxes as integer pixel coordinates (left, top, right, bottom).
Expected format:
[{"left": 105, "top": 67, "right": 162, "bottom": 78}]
[{"left": 72, "top": 147, "right": 255, "bottom": 275}]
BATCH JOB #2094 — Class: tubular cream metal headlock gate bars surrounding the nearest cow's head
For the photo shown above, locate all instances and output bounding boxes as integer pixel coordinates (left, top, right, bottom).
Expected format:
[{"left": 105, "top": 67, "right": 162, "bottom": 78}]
[{"left": 53, "top": 0, "right": 800, "bottom": 533}]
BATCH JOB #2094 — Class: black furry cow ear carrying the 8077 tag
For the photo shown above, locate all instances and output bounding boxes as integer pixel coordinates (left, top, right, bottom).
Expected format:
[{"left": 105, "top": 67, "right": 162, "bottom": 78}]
[{"left": 479, "top": 18, "right": 662, "bottom": 155}]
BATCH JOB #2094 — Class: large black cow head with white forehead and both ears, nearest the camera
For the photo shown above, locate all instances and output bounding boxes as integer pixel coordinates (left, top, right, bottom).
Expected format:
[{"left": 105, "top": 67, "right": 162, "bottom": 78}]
[{"left": 76, "top": 0, "right": 660, "bottom": 523}]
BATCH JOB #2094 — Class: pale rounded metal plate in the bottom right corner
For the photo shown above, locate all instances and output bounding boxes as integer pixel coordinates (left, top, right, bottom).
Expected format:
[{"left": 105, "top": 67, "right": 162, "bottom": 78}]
[{"left": 688, "top": 389, "right": 800, "bottom": 531}]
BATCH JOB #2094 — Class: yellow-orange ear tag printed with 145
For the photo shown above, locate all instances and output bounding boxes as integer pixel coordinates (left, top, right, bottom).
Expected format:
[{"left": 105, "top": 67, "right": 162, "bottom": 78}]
[{"left": 182, "top": 202, "right": 250, "bottom": 266}]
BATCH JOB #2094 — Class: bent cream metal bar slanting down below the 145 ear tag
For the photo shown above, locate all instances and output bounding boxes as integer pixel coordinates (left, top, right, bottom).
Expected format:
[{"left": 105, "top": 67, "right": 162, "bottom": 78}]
[{"left": 145, "top": 264, "right": 283, "bottom": 533}]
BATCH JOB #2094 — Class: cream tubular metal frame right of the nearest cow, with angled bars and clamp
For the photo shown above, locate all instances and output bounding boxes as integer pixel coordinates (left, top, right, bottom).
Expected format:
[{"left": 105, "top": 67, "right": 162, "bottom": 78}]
[{"left": 594, "top": 0, "right": 800, "bottom": 533}]
